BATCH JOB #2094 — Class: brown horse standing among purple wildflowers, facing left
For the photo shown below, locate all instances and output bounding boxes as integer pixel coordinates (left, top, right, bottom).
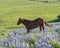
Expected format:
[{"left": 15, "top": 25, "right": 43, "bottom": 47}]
[{"left": 17, "top": 18, "right": 51, "bottom": 33}]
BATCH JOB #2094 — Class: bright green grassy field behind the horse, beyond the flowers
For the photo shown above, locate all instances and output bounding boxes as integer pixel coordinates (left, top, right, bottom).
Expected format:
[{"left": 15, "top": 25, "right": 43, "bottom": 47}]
[{"left": 0, "top": 0, "right": 60, "bottom": 34}]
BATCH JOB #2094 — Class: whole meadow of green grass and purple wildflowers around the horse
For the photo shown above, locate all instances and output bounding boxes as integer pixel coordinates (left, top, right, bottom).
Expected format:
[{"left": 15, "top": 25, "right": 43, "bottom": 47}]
[{"left": 0, "top": 0, "right": 60, "bottom": 48}]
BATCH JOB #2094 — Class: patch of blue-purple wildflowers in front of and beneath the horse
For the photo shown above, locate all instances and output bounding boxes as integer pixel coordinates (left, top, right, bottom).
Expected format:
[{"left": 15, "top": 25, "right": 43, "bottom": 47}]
[{"left": 0, "top": 23, "right": 60, "bottom": 48}]
